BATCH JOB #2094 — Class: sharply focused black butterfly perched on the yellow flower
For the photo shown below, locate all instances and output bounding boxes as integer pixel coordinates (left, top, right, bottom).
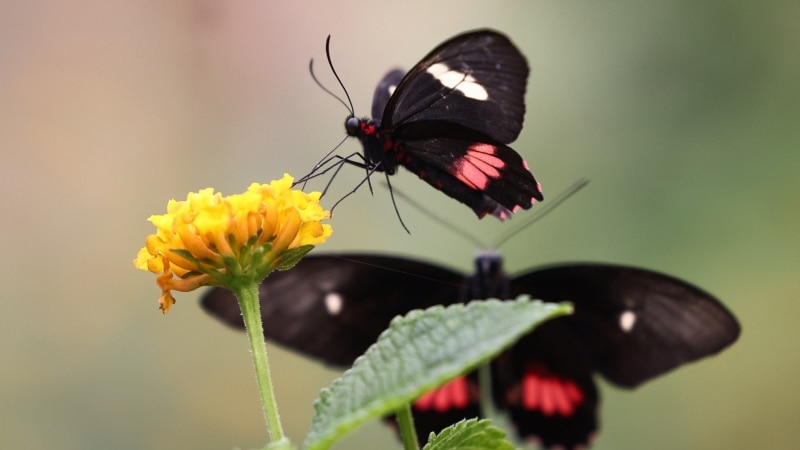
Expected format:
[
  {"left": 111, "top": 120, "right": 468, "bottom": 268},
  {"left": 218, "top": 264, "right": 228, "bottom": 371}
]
[{"left": 310, "top": 30, "right": 544, "bottom": 220}]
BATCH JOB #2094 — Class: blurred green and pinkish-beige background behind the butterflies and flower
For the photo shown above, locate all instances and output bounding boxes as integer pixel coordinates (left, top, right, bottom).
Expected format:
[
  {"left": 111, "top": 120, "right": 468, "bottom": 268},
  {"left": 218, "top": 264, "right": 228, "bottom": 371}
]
[{"left": 0, "top": 0, "right": 800, "bottom": 449}]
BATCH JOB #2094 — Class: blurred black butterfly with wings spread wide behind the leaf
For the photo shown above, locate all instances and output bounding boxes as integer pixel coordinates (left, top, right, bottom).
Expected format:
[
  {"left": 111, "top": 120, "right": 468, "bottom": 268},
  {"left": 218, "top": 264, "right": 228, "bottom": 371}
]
[{"left": 202, "top": 253, "right": 739, "bottom": 449}]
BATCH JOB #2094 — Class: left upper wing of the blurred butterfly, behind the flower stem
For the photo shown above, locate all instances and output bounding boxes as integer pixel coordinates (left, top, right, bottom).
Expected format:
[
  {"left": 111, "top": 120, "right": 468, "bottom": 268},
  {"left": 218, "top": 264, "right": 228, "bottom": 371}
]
[{"left": 201, "top": 254, "right": 463, "bottom": 367}]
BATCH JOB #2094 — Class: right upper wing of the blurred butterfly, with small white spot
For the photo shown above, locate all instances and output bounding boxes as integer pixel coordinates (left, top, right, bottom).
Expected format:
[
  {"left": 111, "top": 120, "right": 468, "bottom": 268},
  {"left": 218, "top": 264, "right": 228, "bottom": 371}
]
[{"left": 511, "top": 264, "right": 740, "bottom": 387}]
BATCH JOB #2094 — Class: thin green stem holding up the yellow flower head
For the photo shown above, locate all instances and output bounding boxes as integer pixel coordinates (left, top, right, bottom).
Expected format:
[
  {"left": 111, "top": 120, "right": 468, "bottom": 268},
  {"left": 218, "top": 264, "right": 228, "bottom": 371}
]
[{"left": 234, "top": 282, "right": 291, "bottom": 449}]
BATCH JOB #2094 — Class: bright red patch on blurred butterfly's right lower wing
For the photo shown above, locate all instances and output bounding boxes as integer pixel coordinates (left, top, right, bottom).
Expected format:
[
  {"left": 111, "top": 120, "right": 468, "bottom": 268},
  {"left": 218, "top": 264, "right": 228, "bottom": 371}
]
[{"left": 519, "top": 364, "right": 584, "bottom": 417}]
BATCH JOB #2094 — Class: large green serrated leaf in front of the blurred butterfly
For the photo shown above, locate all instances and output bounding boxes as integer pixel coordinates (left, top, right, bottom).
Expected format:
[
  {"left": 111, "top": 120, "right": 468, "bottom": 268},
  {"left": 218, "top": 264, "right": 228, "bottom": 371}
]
[{"left": 303, "top": 296, "right": 572, "bottom": 450}]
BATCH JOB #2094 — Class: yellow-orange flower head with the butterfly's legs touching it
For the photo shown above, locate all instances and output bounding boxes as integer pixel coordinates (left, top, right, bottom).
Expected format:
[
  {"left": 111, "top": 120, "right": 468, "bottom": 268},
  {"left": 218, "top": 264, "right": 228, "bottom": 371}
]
[{"left": 133, "top": 174, "right": 333, "bottom": 314}]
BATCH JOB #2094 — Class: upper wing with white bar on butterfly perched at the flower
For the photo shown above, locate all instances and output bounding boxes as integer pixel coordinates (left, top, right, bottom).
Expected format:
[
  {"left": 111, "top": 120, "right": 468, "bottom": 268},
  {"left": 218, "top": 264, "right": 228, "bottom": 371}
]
[{"left": 382, "top": 30, "right": 529, "bottom": 144}]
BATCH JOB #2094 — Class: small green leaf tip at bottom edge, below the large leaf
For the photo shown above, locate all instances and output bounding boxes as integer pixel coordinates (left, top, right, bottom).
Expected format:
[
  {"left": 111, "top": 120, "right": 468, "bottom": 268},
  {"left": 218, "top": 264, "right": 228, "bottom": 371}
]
[{"left": 422, "top": 419, "right": 514, "bottom": 450}]
